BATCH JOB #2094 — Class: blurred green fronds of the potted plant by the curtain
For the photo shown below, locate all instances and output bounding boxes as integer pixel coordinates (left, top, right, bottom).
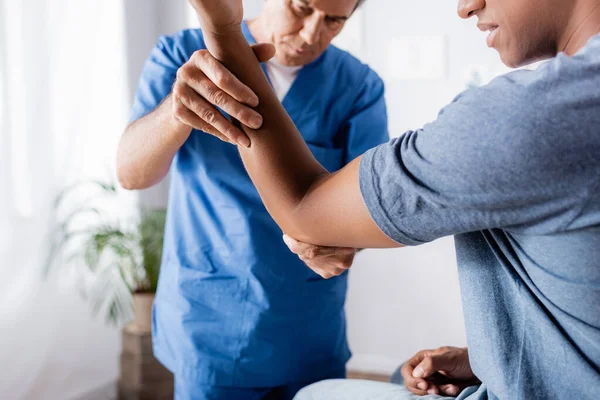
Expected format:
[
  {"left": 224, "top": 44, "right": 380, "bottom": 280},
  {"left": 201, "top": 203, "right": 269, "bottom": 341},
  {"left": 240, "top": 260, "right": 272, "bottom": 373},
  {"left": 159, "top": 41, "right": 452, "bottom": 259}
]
[{"left": 44, "top": 181, "right": 166, "bottom": 325}]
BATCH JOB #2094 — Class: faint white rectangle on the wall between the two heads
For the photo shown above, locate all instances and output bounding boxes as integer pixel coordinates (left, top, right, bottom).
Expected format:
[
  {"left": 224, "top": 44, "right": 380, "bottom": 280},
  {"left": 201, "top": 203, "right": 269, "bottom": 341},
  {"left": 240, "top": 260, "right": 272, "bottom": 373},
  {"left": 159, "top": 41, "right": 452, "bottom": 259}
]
[{"left": 386, "top": 35, "right": 448, "bottom": 80}]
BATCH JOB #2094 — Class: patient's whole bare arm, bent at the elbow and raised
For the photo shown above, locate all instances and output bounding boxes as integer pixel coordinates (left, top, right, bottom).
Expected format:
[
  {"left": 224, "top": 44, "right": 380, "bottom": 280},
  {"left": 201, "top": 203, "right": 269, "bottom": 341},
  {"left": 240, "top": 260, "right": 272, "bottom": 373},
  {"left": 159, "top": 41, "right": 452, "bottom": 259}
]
[{"left": 190, "top": 0, "right": 399, "bottom": 248}]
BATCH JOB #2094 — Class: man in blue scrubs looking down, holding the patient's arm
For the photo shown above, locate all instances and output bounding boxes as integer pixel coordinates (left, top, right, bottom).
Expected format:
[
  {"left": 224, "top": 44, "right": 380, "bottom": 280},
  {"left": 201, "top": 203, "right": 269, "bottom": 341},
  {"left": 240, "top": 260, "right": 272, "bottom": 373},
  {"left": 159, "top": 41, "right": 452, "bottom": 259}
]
[{"left": 118, "top": 0, "right": 388, "bottom": 400}]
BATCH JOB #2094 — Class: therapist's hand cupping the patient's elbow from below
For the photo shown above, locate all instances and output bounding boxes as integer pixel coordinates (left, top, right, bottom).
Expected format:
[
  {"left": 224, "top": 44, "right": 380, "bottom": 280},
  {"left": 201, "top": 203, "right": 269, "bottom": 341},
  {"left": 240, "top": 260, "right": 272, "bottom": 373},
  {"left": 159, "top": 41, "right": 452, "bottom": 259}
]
[{"left": 283, "top": 235, "right": 356, "bottom": 279}]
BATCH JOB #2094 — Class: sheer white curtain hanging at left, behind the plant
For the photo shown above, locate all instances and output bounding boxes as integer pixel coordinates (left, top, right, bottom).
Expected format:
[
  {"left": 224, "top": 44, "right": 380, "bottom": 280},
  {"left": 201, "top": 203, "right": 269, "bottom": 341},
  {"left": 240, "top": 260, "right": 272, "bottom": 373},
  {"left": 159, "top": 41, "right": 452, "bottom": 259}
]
[{"left": 0, "top": 0, "right": 129, "bottom": 400}]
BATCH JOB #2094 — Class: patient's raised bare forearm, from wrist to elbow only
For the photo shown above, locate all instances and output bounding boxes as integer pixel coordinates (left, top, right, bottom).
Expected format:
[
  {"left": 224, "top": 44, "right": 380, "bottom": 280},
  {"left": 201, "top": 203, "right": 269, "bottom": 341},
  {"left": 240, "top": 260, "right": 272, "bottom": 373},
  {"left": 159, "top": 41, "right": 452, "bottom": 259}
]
[{"left": 205, "top": 31, "right": 329, "bottom": 239}]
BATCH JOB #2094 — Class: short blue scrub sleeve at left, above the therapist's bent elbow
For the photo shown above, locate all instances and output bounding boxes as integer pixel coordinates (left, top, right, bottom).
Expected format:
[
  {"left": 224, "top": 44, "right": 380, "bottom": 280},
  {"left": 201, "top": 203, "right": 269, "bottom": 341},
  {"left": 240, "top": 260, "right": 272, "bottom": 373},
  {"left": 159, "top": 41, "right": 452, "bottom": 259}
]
[{"left": 129, "top": 36, "right": 185, "bottom": 122}]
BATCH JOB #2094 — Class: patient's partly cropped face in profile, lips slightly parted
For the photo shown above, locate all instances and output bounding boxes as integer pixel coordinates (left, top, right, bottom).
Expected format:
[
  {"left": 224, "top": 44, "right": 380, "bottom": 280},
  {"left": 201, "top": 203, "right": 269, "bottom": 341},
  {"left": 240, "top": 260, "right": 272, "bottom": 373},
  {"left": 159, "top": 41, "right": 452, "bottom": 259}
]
[{"left": 458, "top": 0, "right": 574, "bottom": 67}]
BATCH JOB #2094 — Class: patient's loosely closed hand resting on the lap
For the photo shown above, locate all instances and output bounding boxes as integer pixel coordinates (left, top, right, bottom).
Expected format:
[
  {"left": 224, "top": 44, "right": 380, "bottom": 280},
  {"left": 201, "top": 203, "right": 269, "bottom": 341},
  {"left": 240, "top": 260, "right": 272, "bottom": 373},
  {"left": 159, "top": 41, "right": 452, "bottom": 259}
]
[{"left": 400, "top": 347, "right": 481, "bottom": 397}]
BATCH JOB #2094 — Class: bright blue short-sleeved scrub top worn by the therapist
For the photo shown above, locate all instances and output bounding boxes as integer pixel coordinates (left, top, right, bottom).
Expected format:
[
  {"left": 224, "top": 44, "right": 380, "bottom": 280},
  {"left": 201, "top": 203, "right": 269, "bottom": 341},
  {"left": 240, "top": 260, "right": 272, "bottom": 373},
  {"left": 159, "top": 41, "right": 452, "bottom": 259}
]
[{"left": 132, "top": 23, "right": 388, "bottom": 387}]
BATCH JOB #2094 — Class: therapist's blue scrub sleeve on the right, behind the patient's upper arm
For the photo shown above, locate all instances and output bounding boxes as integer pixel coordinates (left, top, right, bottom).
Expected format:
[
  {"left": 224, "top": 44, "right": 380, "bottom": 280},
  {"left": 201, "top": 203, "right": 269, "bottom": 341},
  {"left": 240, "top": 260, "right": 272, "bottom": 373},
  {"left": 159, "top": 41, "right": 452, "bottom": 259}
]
[{"left": 344, "top": 69, "right": 389, "bottom": 163}]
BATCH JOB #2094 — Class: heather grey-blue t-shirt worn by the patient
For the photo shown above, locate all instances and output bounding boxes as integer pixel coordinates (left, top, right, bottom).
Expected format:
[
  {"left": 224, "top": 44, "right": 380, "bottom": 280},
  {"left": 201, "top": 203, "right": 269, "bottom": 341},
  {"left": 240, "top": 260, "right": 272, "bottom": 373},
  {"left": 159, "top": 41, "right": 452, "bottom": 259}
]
[{"left": 360, "top": 36, "right": 600, "bottom": 399}]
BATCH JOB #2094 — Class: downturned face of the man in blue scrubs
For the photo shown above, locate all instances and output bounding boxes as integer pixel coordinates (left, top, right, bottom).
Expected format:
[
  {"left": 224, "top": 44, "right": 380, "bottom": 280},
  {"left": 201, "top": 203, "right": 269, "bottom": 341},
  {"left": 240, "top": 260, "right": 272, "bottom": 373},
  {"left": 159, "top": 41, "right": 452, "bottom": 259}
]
[{"left": 262, "top": 0, "right": 358, "bottom": 66}]
